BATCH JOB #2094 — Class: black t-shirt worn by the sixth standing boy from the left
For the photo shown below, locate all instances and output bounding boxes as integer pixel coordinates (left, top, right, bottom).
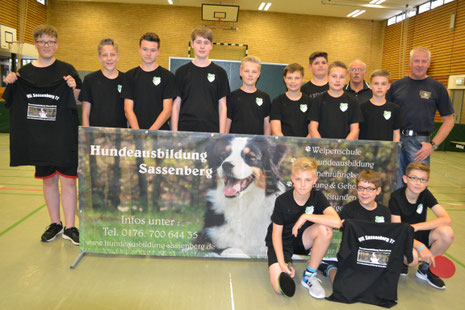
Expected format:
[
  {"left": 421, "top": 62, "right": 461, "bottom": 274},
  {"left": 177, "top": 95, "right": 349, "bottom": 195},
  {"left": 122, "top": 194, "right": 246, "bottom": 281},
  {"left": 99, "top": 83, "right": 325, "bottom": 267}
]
[{"left": 270, "top": 93, "right": 311, "bottom": 137}]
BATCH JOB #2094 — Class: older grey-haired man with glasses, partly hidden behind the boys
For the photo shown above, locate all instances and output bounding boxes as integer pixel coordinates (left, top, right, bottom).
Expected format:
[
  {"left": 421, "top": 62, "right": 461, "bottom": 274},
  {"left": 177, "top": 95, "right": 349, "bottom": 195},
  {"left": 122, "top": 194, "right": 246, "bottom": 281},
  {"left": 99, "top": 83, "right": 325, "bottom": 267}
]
[{"left": 344, "top": 59, "right": 373, "bottom": 103}]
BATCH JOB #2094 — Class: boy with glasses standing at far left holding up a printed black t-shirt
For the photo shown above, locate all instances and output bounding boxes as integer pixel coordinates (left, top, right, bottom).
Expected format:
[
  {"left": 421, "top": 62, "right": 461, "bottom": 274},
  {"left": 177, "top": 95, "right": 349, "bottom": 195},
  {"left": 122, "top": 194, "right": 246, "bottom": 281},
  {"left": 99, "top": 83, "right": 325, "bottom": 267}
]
[{"left": 3, "top": 25, "right": 82, "bottom": 245}]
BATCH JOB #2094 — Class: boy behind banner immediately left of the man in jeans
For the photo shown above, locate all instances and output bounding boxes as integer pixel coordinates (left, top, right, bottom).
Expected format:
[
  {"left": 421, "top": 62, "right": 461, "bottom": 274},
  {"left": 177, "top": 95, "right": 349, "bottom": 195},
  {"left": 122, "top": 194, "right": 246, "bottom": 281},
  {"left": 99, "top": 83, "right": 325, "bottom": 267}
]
[{"left": 359, "top": 69, "right": 402, "bottom": 142}]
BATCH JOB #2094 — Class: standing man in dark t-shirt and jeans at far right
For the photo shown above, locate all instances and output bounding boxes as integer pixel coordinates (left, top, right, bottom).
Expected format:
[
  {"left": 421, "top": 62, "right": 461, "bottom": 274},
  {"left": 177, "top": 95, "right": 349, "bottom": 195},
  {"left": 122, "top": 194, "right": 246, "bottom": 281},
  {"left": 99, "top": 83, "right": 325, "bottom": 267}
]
[{"left": 386, "top": 47, "right": 454, "bottom": 188}]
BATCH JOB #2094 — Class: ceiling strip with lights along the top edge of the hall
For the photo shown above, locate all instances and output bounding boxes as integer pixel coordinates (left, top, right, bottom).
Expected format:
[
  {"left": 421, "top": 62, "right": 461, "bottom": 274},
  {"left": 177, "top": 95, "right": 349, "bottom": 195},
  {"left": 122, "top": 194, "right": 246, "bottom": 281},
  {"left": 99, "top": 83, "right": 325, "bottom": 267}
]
[{"left": 58, "top": 0, "right": 427, "bottom": 20}]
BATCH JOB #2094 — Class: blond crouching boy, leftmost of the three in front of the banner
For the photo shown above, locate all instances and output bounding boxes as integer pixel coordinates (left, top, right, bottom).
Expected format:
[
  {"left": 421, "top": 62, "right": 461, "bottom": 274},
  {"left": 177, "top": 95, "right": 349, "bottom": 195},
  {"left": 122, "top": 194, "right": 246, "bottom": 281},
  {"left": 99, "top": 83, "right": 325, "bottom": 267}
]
[{"left": 265, "top": 157, "right": 341, "bottom": 299}]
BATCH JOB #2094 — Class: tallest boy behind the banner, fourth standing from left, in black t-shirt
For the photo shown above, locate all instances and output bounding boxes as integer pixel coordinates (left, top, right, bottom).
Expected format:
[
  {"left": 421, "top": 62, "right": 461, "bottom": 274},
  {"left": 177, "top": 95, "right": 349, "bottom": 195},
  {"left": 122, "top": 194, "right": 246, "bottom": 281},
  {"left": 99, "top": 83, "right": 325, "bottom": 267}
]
[{"left": 171, "top": 27, "right": 229, "bottom": 133}]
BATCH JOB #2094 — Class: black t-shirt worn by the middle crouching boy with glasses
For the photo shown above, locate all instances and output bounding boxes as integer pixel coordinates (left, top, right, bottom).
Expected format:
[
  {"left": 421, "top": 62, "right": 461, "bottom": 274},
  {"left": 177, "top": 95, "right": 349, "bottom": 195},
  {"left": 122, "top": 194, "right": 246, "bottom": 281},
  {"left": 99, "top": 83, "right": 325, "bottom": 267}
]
[{"left": 339, "top": 200, "right": 391, "bottom": 223}]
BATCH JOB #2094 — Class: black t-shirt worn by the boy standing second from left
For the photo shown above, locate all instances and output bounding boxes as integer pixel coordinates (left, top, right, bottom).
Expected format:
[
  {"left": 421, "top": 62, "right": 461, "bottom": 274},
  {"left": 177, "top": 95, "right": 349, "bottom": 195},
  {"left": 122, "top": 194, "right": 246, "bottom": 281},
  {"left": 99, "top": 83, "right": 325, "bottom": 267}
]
[{"left": 79, "top": 70, "right": 127, "bottom": 128}]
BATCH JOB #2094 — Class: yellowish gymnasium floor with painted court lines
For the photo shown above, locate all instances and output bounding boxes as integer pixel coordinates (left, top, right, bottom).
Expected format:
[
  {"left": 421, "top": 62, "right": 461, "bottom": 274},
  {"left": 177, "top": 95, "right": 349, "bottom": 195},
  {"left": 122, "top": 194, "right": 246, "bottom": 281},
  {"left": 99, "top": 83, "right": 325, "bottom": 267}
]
[{"left": 0, "top": 134, "right": 465, "bottom": 310}]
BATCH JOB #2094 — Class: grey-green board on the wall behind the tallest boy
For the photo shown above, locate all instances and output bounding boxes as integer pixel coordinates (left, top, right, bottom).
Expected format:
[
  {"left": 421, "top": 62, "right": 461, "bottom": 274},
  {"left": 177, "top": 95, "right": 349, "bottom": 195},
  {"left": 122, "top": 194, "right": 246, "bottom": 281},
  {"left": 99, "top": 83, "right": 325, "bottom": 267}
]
[{"left": 169, "top": 57, "right": 287, "bottom": 100}]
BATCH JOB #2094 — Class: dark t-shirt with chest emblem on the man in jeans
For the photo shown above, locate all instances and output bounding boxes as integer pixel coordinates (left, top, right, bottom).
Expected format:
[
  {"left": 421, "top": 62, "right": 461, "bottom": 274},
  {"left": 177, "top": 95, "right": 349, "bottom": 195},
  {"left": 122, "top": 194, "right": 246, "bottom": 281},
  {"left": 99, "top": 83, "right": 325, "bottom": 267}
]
[{"left": 386, "top": 76, "right": 454, "bottom": 133}]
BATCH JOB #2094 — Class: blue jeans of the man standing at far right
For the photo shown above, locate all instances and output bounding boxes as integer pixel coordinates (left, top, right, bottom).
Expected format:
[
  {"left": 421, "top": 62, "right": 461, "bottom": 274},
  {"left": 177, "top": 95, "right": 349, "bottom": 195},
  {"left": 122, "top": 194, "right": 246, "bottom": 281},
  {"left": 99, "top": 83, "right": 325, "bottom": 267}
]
[{"left": 396, "top": 135, "right": 430, "bottom": 188}]
